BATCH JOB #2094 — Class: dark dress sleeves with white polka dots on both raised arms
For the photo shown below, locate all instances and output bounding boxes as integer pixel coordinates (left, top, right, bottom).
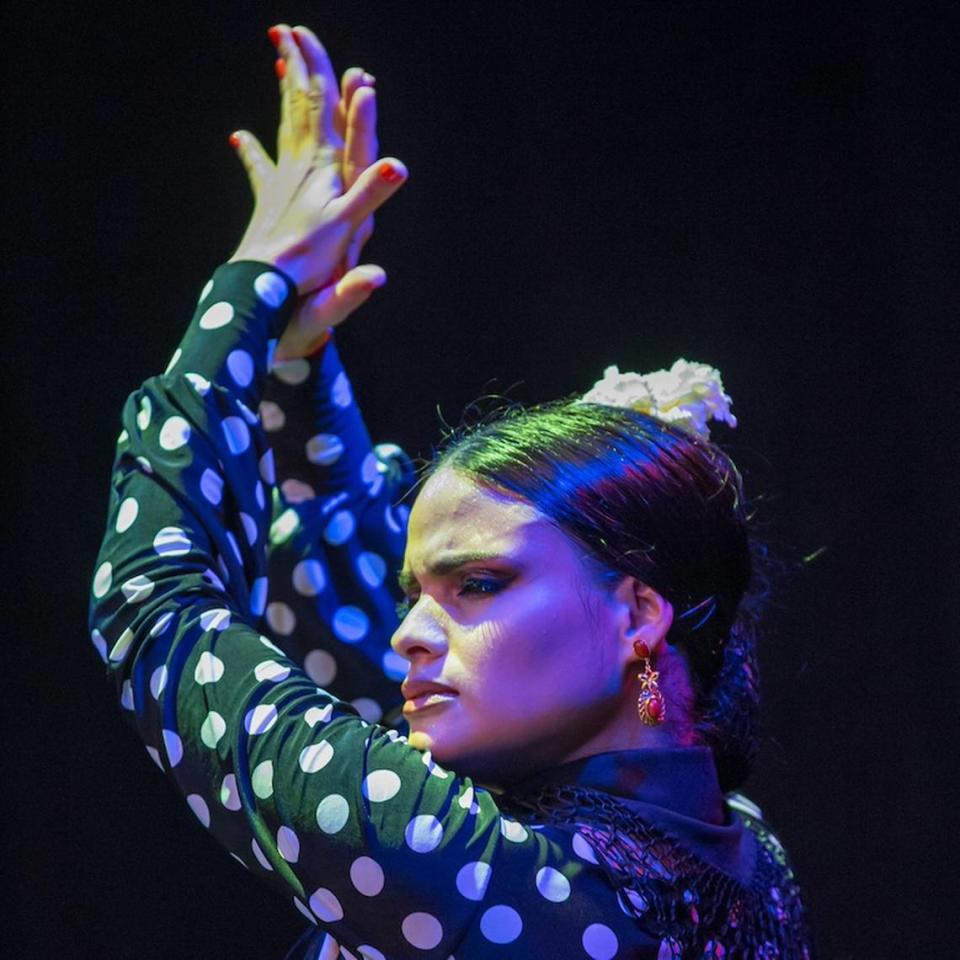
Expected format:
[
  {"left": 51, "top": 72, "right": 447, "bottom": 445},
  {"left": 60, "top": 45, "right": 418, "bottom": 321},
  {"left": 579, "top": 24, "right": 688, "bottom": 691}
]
[{"left": 91, "top": 262, "right": 808, "bottom": 960}]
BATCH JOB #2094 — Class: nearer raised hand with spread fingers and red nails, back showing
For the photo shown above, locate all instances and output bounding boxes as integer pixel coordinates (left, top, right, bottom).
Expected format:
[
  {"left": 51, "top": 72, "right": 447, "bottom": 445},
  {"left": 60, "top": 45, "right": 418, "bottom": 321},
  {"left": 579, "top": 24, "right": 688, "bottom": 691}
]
[{"left": 231, "top": 24, "right": 406, "bottom": 306}]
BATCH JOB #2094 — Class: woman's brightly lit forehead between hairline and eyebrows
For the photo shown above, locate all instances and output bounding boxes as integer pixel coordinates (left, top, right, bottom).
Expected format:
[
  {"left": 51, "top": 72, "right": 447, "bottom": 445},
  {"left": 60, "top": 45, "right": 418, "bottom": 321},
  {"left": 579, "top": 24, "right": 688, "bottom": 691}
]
[{"left": 407, "top": 468, "right": 548, "bottom": 563}]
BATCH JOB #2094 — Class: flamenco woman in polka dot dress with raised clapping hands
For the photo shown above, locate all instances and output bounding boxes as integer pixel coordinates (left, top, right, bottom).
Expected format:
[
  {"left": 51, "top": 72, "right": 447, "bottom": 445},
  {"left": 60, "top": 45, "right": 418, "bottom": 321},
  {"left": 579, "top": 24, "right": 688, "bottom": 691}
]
[{"left": 92, "top": 25, "right": 809, "bottom": 960}]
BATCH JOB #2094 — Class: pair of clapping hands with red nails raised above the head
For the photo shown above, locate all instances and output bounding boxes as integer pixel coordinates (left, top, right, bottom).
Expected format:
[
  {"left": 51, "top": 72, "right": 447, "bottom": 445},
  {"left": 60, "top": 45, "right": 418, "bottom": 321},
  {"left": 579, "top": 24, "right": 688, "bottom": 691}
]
[{"left": 231, "top": 24, "right": 406, "bottom": 359}]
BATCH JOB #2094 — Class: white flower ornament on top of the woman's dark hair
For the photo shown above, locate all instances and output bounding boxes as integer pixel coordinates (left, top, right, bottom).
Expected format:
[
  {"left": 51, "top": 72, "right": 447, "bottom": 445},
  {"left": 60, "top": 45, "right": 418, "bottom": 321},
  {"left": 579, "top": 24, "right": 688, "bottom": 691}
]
[{"left": 577, "top": 358, "right": 737, "bottom": 440}]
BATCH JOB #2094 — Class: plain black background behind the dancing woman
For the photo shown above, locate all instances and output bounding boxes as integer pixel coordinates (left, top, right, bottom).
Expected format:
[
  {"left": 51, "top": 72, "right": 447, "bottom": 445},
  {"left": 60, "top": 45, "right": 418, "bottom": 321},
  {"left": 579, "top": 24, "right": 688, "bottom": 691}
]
[{"left": 0, "top": 0, "right": 960, "bottom": 960}]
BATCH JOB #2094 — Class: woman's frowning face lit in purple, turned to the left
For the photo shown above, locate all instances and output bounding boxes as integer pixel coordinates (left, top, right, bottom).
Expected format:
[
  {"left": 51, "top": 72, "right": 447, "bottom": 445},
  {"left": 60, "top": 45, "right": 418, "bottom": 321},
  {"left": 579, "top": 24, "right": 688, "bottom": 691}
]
[{"left": 392, "top": 469, "right": 628, "bottom": 785}]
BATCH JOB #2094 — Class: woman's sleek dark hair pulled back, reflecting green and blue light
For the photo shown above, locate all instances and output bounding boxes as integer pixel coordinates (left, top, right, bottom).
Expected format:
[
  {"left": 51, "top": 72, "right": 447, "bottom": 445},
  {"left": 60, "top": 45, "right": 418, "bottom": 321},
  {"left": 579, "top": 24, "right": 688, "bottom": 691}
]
[{"left": 429, "top": 400, "right": 767, "bottom": 790}]
